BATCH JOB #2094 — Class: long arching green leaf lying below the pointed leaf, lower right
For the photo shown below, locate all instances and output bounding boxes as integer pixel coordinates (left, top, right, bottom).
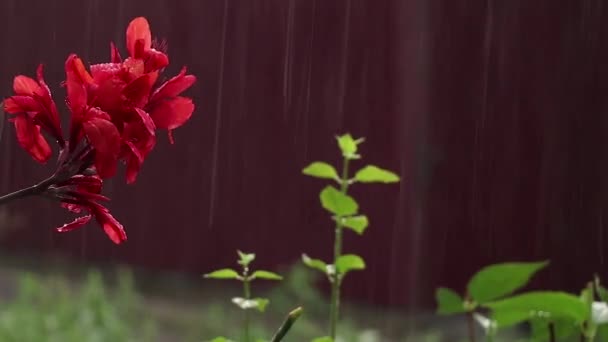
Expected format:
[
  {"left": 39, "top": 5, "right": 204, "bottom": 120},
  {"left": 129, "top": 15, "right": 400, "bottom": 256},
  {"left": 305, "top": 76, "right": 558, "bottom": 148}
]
[{"left": 483, "top": 291, "right": 589, "bottom": 323}]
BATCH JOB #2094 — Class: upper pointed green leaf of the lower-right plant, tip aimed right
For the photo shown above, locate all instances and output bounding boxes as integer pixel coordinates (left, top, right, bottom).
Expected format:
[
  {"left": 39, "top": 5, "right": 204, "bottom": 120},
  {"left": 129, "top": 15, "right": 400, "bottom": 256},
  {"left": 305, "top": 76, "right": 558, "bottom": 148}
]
[{"left": 467, "top": 261, "right": 548, "bottom": 303}]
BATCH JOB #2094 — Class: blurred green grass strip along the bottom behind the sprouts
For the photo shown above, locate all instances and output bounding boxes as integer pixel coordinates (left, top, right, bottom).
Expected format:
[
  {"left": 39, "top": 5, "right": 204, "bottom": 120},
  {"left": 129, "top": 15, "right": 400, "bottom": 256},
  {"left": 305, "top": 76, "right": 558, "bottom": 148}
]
[{"left": 0, "top": 250, "right": 524, "bottom": 342}]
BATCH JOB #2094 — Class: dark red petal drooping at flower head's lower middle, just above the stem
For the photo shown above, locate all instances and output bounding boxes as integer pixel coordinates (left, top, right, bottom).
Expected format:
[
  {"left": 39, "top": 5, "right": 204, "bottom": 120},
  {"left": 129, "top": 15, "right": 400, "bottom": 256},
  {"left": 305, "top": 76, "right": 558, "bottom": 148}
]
[{"left": 83, "top": 117, "right": 120, "bottom": 178}]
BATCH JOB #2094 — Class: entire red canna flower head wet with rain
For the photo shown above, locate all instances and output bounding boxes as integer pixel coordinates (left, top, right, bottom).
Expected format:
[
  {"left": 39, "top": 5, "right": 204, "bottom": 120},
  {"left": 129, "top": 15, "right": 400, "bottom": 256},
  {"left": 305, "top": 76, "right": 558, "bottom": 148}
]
[{"left": 4, "top": 17, "right": 196, "bottom": 244}]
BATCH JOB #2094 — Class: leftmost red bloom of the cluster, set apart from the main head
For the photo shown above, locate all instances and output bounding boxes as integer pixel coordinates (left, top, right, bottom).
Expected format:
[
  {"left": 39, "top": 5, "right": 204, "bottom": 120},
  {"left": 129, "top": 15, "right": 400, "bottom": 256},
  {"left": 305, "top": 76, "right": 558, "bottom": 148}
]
[{"left": 4, "top": 65, "right": 65, "bottom": 163}]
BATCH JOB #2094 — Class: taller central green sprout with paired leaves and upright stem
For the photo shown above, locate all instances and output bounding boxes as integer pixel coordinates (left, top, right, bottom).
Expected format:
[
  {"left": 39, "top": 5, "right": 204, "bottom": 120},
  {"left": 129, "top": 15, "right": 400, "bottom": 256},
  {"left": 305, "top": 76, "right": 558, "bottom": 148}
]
[{"left": 302, "top": 134, "right": 399, "bottom": 341}]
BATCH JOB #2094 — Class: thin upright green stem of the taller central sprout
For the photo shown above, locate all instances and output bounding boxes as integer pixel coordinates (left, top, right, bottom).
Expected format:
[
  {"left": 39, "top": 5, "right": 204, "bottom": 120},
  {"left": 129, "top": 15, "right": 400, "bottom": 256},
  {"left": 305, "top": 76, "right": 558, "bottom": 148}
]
[{"left": 329, "top": 157, "right": 349, "bottom": 340}]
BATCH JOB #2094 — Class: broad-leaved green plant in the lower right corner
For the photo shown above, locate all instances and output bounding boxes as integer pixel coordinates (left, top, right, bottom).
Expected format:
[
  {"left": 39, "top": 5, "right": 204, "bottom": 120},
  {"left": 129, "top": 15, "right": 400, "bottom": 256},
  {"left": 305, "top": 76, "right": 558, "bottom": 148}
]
[{"left": 436, "top": 261, "right": 608, "bottom": 342}]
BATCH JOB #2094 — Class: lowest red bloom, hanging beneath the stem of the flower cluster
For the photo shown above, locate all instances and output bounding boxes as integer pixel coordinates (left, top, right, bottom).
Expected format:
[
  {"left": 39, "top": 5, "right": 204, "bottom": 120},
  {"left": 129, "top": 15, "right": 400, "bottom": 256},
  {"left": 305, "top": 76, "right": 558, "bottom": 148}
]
[{"left": 48, "top": 175, "right": 127, "bottom": 244}]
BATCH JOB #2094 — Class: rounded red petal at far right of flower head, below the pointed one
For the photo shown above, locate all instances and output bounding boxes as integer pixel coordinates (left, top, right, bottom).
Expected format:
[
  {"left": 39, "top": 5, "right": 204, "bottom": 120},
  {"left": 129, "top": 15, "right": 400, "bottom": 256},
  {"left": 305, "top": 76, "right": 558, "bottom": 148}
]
[{"left": 150, "top": 96, "right": 194, "bottom": 129}]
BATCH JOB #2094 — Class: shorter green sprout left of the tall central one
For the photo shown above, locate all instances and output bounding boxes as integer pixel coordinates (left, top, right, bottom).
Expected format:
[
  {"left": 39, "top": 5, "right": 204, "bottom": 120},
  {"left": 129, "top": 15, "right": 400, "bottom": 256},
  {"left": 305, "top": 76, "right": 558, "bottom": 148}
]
[{"left": 204, "top": 251, "right": 283, "bottom": 342}]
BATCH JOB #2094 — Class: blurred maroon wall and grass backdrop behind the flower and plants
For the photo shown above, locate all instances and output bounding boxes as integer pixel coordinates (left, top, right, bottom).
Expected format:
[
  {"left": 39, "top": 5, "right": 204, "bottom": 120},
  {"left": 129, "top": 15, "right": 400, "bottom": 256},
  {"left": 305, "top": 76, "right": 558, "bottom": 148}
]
[{"left": 0, "top": 0, "right": 608, "bottom": 341}]
